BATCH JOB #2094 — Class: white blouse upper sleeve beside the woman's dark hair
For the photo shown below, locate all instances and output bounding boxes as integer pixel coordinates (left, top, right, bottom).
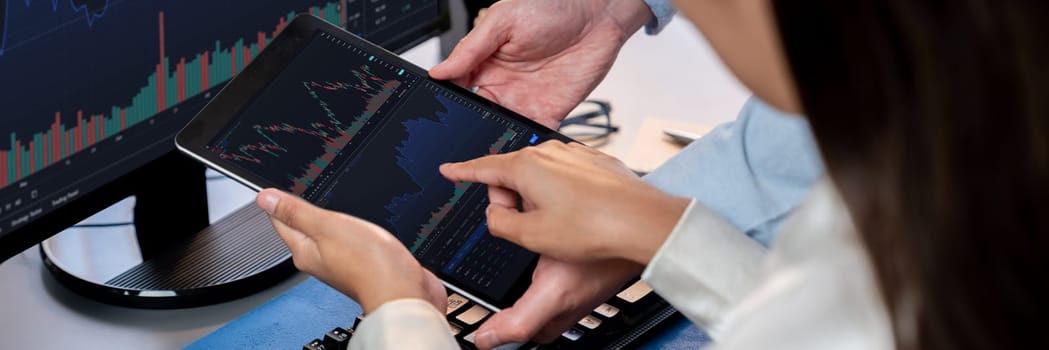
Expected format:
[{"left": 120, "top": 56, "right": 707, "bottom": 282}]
[{"left": 714, "top": 181, "right": 895, "bottom": 350}]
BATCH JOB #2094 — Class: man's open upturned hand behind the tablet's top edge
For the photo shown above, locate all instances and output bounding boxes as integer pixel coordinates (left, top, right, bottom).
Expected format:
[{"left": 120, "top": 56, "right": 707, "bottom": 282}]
[{"left": 430, "top": 0, "right": 652, "bottom": 128}]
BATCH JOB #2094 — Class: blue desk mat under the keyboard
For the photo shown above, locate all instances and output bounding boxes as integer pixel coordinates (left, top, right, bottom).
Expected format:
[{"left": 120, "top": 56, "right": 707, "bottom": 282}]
[{"left": 187, "top": 278, "right": 710, "bottom": 349}]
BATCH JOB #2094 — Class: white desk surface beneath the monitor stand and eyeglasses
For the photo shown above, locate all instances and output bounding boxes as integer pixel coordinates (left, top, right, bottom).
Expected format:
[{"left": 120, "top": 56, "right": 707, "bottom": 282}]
[{"left": 0, "top": 18, "right": 749, "bottom": 349}]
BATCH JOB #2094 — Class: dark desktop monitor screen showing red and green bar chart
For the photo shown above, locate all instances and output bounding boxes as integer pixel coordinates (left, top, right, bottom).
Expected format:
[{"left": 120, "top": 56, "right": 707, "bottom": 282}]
[{"left": 0, "top": 0, "right": 356, "bottom": 191}]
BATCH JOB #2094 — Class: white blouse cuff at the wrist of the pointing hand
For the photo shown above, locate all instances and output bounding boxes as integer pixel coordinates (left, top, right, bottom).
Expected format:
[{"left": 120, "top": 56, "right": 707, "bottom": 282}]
[{"left": 641, "top": 200, "right": 766, "bottom": 340}]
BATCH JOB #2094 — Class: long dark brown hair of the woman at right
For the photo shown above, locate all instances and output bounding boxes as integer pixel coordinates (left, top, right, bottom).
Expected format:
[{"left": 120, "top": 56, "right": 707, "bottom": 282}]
[{"left": 772, "top": 0, "right": 1049, "bottom": 349}]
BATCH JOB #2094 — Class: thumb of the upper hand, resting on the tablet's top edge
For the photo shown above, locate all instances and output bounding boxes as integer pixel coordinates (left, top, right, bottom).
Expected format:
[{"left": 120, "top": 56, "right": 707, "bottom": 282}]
[{"left": 430, "top": 12, "right": 508, "bottom": 80}]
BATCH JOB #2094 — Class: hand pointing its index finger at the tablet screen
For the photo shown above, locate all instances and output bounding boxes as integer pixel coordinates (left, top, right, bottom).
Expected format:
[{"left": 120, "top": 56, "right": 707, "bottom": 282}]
[{"left": 441, "top": 140, "right": 689, "bottom": 265}]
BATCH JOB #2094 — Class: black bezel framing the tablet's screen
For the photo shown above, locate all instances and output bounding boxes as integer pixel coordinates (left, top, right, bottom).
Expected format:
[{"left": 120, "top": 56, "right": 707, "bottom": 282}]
[{"left": 175, "top": 15, "right": 573, "bottom": 311}]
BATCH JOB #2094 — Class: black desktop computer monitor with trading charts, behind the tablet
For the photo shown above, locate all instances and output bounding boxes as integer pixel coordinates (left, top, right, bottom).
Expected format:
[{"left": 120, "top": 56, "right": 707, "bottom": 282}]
[{"left": 0, "top": 0, "right": 448, "bottom": 303}]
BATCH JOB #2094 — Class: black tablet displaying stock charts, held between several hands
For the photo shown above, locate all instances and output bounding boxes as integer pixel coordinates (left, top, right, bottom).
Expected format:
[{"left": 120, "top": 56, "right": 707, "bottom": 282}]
[{"left": 176, "top": 15, "right": 570, "bottom": 310}]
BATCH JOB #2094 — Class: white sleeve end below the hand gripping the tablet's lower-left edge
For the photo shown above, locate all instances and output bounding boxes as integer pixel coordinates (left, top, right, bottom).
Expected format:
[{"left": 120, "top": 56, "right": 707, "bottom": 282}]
[{"left": 349, "top": 299, "right": 459, "bottom": 349}]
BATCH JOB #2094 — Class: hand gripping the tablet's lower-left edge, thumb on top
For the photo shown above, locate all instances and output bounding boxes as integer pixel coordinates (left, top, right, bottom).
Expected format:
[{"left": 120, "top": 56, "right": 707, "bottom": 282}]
[{"left": 256, "top": 189, "right": 448, "bottom": 313}]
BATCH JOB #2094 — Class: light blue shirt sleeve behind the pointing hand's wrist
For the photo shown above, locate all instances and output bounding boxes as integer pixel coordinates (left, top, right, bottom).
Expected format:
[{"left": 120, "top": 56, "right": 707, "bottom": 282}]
[{"left": 645, "top": 97, "right": 823, "bottom": 246}]
